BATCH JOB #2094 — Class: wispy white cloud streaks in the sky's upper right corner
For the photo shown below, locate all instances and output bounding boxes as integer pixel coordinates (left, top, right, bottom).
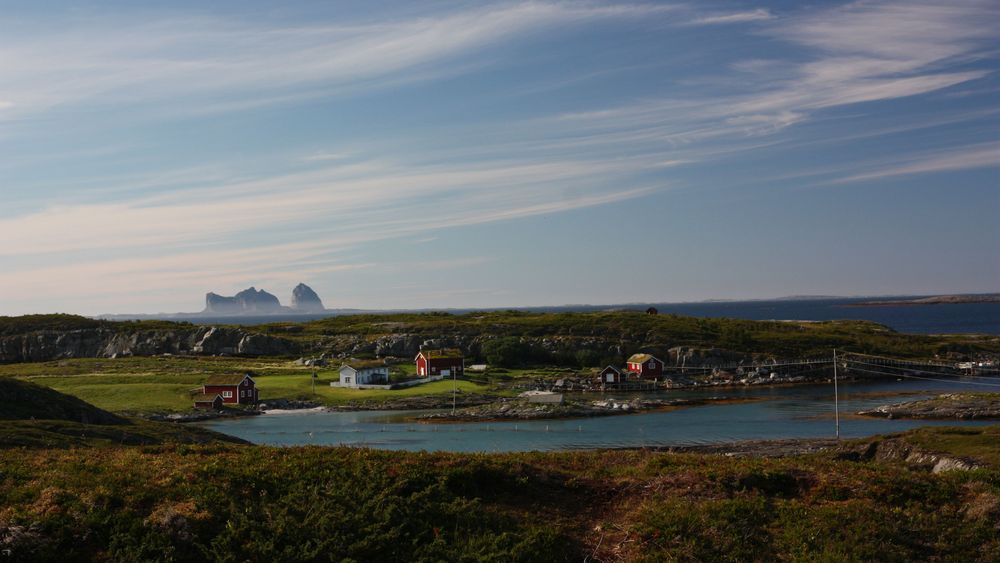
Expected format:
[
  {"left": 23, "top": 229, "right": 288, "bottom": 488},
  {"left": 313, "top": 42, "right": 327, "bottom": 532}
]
[{"left": 546, "top": 1, "right": 1000, "bottom": 169}]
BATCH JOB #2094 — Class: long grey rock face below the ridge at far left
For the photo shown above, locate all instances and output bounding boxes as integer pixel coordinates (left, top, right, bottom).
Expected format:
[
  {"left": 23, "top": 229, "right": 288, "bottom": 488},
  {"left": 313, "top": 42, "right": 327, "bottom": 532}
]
[{"left": 0, "top": 326, "right": 299, "bottom": 363}]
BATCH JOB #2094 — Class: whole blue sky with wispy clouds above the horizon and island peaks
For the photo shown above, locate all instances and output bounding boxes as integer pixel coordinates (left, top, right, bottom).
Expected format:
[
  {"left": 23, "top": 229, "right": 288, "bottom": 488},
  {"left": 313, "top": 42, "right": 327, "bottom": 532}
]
[{"left": 0, "top": 0, "right": 1000, "bottom": 315}]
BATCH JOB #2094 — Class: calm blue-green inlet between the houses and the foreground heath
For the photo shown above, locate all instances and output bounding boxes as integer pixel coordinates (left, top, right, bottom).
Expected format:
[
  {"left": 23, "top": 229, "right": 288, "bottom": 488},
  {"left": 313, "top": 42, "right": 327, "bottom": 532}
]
[{"left": 199, "top": 381, "right": 989, "bottom": 452}]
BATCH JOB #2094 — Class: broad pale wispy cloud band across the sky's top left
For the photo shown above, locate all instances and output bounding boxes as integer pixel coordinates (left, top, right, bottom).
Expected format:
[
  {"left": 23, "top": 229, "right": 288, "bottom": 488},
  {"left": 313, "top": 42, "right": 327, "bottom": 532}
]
[{"left": 0, "top": 2, "right": 672, "bottom": 118}]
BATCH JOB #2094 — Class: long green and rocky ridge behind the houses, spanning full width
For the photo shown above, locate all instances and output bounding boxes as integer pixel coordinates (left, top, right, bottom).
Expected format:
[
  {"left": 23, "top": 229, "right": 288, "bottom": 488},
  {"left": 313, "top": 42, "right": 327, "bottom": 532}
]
[{"left": 0, "top": 311, "right": 1000, "bottom": 367}]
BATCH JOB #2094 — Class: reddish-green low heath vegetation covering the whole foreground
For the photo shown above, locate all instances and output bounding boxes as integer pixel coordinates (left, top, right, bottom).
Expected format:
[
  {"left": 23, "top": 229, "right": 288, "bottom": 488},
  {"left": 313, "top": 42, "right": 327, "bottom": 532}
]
[{"left": 0, "top": 427, "right": 1000, "bottom": 561}]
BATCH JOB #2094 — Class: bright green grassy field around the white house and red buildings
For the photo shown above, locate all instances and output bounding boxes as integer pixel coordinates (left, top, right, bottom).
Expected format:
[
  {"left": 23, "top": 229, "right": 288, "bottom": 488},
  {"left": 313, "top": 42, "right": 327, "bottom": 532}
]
[{"left": 0, "top": 357, "right": 489, "bottom": 412}]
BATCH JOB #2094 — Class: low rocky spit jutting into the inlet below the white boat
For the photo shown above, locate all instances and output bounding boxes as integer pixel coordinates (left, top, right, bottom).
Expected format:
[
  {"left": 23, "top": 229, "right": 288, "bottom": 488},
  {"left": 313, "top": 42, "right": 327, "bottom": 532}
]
[{"left": 414, "top": 397, "right": 741, "bottom": 422}]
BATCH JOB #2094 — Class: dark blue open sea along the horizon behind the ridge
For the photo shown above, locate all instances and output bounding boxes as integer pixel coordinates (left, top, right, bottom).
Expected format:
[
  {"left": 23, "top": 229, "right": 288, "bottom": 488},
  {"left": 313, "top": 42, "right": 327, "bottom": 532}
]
[{"left": 143, "top": 298, "right": 1000, "bottom": 334}]
